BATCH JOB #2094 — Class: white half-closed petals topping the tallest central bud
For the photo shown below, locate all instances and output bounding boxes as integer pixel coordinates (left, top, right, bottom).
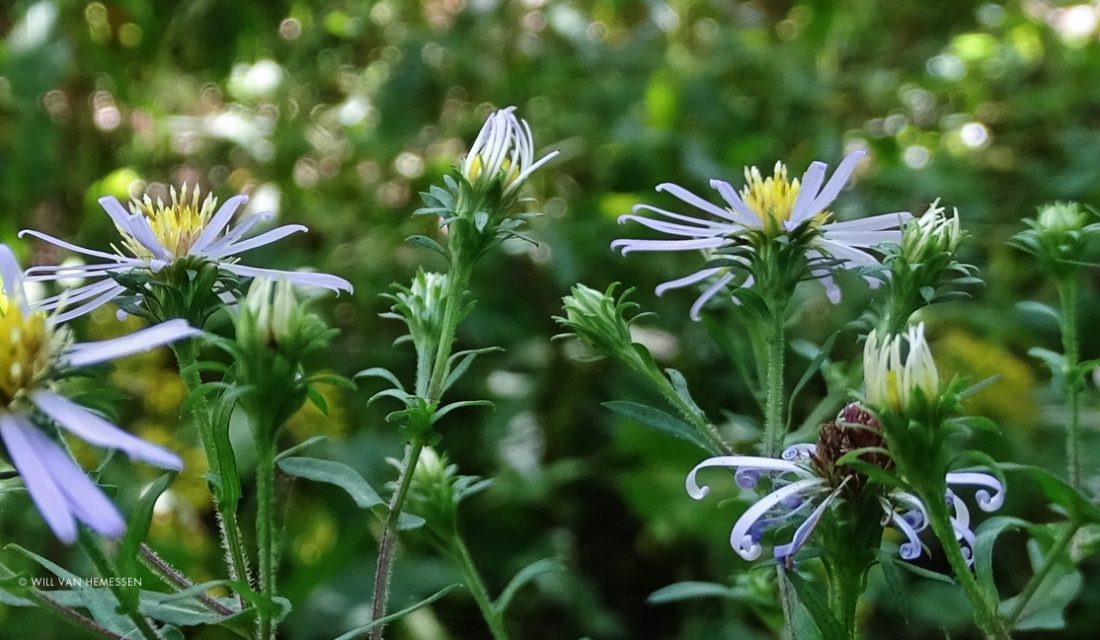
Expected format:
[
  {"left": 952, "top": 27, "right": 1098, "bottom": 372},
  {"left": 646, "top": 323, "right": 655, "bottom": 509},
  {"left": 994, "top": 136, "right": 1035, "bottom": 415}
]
[{"left": 462, "top": 107, "right": 558, "bottom": 197}]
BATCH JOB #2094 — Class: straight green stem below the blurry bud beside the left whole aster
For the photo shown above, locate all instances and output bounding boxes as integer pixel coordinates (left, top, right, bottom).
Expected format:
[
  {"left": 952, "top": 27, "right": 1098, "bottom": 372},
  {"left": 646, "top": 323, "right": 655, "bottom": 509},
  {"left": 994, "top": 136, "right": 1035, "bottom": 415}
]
[{"left": 256, "top": 438, "right": 277, "bottom": 640}]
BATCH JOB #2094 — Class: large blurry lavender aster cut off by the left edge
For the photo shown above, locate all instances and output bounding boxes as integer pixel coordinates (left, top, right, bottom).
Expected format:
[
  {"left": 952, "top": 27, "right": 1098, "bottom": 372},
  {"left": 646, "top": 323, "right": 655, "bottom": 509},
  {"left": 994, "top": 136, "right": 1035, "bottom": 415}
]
[{"left": 0, "top": 244, "right": 198, "bottom": 543}]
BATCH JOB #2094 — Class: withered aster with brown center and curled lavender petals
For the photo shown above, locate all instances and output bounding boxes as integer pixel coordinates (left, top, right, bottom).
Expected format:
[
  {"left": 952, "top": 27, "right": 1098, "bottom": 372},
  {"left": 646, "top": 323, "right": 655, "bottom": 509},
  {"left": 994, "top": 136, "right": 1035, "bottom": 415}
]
[{"left": 686, "top": 405, "right": 1004, "bottom": 562}]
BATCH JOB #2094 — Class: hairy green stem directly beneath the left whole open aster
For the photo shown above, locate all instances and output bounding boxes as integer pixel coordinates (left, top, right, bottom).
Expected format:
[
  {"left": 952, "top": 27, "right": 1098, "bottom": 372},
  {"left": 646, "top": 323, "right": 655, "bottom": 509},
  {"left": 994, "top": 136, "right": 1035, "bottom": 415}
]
[{"left": 173, "top": 341, "right": 252, "bottom": 598}]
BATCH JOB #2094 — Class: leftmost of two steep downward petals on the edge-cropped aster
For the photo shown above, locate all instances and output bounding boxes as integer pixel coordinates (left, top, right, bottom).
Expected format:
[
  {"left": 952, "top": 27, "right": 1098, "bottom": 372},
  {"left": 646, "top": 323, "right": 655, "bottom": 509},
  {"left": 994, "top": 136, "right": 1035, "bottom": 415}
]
[{"left": 0, "top": 411, "right": 76, "bottom": 544}]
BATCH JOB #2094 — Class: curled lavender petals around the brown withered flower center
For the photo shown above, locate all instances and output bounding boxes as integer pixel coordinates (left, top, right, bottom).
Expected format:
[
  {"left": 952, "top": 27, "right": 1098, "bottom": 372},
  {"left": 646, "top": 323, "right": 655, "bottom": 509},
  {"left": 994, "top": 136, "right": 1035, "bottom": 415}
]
[{"left": 685, "top": 444, "right": 1004, "bottom": 561}]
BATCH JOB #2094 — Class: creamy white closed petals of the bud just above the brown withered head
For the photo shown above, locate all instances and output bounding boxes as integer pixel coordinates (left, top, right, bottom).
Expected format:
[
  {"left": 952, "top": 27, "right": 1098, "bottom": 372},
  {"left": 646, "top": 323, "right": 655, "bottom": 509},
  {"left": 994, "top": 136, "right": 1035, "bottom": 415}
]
[{"left": 864, "top": 323, "right": 939, "bottom": 412}]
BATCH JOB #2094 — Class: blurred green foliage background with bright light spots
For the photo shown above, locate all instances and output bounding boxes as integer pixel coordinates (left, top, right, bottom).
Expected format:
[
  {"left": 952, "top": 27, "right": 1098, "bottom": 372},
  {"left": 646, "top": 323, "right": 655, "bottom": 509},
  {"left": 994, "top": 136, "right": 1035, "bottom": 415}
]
[{"left": 0, "top": 0, "right": 1100, "bottom": 640}]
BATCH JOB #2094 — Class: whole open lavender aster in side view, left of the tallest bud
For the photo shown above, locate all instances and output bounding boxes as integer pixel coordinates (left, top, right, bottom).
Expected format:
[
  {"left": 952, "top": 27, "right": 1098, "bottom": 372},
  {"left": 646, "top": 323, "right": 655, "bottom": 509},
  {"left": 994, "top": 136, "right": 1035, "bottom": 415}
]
[{"left": 20, "top": 184, "right": 352, "bottom": 322}]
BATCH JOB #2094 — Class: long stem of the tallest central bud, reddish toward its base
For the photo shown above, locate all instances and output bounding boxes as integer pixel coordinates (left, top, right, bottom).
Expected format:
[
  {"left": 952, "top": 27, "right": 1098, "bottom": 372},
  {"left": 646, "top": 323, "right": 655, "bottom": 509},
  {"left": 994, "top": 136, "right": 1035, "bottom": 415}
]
[{"left": 370, "top": 256, "right": 472, "bottom": 640}]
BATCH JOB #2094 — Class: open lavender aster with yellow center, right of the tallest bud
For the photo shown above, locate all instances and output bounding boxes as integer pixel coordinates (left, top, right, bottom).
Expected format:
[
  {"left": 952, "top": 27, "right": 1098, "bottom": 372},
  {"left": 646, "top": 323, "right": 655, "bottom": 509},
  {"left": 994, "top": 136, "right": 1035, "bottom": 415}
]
[{"left": 612, "top": 151, "right": 912, "bottom": 320}]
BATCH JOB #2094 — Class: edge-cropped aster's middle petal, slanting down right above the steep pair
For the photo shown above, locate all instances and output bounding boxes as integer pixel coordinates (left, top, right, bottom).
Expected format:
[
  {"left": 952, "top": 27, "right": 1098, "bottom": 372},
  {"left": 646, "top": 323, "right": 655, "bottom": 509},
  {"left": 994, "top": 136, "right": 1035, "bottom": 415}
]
[{"left": 30, "top": 389, "right": 184, "bottom": 471}]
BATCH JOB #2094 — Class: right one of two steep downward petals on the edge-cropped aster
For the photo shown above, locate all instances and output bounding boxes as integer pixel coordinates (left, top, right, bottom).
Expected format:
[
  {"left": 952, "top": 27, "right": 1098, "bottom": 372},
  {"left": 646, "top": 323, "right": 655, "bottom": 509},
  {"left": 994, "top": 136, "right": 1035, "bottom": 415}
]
[{"left": 20, "top": 428, "right": 127, "bottom": 538}]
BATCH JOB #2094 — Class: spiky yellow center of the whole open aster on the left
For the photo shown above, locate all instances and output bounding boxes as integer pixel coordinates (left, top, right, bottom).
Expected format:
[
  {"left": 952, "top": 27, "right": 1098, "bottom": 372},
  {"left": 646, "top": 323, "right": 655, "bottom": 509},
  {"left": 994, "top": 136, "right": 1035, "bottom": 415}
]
[{"left": 124, "top": 184, "right": 218, "bottom": 258}]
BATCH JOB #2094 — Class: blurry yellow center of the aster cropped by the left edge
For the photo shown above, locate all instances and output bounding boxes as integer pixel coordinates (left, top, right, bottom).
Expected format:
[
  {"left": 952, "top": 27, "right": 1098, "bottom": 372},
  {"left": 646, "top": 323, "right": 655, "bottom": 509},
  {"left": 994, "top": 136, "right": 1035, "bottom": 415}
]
[{"left": 0, "top": 293, "right": 52, "bottom": 407}]
